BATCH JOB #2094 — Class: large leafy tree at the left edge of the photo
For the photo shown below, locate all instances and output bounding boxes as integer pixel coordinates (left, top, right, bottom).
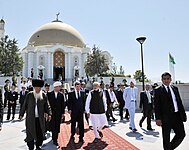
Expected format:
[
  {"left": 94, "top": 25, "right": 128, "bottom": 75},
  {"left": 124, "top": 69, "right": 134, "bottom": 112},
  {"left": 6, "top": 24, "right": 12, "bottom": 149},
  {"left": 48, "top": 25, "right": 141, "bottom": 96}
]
[{"left": 0, "top": 35, "right": 23, "bottom": 76}]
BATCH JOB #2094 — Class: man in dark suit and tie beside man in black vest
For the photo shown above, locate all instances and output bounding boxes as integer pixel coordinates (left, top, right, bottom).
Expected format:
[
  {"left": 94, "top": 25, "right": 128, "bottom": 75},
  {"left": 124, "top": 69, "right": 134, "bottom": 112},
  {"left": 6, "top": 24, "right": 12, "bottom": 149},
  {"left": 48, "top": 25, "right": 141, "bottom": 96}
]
[{"left": 68, "top": 82, "right": 85, "bottom": 142}]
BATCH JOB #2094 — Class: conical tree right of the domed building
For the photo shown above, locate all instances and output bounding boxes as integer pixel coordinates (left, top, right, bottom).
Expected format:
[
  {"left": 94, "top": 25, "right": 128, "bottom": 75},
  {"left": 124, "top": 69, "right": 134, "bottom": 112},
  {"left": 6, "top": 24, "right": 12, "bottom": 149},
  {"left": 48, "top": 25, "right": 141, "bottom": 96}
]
[{"left": 84, "top": 45, "right": 109, "bottom": 76}]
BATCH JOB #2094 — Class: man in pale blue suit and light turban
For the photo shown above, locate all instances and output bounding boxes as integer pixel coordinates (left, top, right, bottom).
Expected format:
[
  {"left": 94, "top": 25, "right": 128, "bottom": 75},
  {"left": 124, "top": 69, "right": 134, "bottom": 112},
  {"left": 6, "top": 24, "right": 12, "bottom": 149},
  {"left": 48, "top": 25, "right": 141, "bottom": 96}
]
[{"left": 123, "top": 80, "right": 138, "bottom": 132}]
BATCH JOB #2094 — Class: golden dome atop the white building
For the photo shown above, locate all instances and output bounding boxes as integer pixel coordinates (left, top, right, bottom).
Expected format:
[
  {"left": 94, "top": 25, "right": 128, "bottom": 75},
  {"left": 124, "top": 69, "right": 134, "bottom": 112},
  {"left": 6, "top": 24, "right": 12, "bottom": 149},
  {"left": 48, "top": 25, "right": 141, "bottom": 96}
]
[{"left": 28, "top": 20, "right": 85, "bottom": 48}]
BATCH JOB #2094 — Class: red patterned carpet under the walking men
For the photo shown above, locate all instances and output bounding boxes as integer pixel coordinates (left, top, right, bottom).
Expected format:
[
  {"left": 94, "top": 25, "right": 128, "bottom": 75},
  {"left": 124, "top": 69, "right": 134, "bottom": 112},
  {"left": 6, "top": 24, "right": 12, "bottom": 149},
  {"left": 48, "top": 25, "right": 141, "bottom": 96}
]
[{"left": 58, "top": 114, "right": 139, "bottom": 150}]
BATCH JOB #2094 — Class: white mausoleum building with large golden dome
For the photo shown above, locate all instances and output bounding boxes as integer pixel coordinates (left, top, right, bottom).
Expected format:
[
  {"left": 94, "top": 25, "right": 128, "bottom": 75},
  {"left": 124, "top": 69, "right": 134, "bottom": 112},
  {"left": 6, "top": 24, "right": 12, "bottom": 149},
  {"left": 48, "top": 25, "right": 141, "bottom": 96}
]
[{"left": 21, "top": 18, "right": 112, "bottom": 82}]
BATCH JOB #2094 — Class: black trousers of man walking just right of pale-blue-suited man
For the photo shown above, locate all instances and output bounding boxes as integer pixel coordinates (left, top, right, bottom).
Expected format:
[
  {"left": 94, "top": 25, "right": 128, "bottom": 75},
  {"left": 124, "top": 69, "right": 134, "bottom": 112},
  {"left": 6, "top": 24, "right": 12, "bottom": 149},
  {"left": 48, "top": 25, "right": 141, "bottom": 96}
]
[{"left": 140, "top": 106, "right": 153, "bottom": 129}]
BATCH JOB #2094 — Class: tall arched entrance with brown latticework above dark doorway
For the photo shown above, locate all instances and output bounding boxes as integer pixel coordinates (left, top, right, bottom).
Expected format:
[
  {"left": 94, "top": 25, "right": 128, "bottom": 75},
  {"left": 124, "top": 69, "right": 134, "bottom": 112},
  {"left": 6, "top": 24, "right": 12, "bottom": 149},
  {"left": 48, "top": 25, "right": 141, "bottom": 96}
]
[{"left": 53, "top": 51, "right": 65, "bottom": 81}]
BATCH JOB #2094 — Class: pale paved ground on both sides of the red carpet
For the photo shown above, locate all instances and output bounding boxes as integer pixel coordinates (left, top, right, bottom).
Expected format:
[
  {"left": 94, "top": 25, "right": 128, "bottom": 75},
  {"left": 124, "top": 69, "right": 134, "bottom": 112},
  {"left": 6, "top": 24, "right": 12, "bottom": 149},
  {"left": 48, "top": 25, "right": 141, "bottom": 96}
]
[{"left": 0, "top": 111, "right": 189, "bottom": 150}]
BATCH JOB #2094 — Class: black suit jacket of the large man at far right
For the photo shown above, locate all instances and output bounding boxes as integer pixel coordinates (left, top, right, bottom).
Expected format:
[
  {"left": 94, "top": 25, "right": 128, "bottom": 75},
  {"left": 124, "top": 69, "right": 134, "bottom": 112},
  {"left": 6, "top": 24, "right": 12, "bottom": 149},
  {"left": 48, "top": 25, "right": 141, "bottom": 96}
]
[{"left": 154, "top": 85, "right": 187, "bottom": 123}]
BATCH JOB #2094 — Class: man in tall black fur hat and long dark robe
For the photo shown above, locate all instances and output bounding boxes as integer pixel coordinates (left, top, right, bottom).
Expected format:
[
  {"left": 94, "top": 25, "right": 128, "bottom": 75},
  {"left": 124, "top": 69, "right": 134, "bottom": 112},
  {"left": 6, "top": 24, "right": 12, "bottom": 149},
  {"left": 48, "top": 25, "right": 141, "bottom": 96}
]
[{"left": 19, "top": 79, "right": 51, "bottom": 150}]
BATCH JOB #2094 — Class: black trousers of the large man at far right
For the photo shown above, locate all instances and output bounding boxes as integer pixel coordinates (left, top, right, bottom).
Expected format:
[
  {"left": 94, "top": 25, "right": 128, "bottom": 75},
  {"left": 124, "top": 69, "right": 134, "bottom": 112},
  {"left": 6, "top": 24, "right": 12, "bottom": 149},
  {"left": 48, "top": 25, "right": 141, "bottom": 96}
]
[{"left": 162, "top": 113, "right": 186, "bottom": 150}]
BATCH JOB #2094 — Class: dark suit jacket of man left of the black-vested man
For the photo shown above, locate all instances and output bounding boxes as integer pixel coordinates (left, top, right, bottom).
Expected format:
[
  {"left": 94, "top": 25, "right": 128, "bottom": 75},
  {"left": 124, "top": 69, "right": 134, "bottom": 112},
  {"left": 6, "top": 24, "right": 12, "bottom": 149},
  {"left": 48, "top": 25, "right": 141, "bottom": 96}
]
[{"left": 68, "top": 90, "right": 85, "bottom": 114}]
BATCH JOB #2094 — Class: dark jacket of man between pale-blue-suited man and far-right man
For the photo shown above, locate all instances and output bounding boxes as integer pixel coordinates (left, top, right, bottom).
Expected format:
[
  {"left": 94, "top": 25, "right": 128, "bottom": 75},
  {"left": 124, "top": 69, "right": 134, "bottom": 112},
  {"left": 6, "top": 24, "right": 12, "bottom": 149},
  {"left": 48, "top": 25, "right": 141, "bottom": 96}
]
[{"left": 139, "top": 91, "right": 153, "bottom": 110}]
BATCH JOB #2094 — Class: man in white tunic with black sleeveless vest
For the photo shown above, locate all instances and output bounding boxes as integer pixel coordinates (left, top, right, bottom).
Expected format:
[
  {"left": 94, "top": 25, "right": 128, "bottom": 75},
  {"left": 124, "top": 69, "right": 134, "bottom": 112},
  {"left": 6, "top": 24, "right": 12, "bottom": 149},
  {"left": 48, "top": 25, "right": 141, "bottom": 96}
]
[{"left": 85, "top": 82, "right": 108, "bottom": 143}]
